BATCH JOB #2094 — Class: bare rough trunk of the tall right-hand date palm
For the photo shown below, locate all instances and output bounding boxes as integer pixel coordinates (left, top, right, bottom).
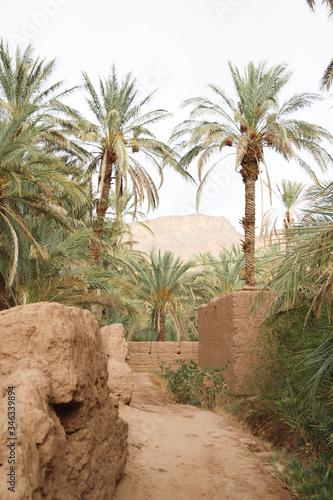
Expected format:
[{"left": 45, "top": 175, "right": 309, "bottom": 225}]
[{"left": 241, "top": 176, "right": 256, "bottom": 286}]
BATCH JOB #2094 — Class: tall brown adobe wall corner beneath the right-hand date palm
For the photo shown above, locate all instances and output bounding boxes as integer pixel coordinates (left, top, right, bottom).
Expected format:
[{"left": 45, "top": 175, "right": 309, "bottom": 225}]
[{"left": 198, "top": 287, "right": 265, "bottom": 386}]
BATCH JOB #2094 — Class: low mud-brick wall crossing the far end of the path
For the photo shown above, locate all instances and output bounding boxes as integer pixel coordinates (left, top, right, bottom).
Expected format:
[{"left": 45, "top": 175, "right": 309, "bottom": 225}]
[{"left": 126, "top": 342, "right": 199, "bottom": 369}]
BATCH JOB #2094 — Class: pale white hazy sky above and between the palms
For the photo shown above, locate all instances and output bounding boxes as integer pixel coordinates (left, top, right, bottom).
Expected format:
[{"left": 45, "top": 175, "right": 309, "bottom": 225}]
[{"left": 0, "top": 0, "right": 333, "bottom": 230}]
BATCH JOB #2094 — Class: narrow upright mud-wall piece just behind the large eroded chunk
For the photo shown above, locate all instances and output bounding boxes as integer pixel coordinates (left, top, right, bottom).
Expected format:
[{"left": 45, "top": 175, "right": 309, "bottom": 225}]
[{"left": 101, "top": 323, "right": 133, "bottom": 404}]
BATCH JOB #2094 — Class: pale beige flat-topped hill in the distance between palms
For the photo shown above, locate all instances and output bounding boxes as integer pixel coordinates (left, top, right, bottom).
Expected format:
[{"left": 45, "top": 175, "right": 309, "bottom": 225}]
[{"left": 131, "top": 214, "right": 253, "bottom": 260}]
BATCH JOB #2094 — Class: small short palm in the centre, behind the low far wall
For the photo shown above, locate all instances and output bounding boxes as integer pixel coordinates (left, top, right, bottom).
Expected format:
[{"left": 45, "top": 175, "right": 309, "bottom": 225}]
[{"left": 133, "top": 250, "right": 210, "bottom": 341}]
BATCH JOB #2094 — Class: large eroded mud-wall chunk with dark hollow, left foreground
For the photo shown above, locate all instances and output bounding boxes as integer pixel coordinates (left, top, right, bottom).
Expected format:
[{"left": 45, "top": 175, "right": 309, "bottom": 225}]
[{"left": 0, "top": 303, "right": 128, "bottom": 500}]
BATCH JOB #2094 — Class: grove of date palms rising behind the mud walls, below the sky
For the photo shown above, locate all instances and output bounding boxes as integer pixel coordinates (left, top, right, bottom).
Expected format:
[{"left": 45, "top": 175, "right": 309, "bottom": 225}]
[{"left": 0, "top": 42, "right": 332, "bottom": 340}]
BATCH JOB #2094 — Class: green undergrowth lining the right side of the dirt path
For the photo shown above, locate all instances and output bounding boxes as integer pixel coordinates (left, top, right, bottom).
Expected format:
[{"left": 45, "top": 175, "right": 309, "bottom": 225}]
[{"left": 159, "top": 304, "right": 333, "bottom": 500}]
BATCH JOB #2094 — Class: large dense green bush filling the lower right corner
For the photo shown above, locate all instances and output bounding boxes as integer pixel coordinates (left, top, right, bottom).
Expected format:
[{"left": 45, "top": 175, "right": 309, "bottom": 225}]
[{"left": 236, "top": 304, "right": 333, "bottom": 500}]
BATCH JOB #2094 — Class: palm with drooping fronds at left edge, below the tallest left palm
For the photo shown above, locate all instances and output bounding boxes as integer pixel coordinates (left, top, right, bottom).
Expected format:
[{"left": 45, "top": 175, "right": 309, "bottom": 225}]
[{"left": 0, "top": 106, "right": 85, "bottom": 309}]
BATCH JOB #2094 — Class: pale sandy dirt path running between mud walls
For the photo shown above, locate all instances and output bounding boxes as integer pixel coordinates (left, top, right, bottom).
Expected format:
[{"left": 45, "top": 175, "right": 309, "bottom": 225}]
[{"left": 115, "top": 373, "right": 290, "bottom": 500}]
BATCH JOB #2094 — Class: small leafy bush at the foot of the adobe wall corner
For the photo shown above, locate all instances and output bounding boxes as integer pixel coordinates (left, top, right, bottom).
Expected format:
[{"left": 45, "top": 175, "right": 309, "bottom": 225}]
[{"left": 160, "top": 359, "right": 228, "bottom": 409}]
